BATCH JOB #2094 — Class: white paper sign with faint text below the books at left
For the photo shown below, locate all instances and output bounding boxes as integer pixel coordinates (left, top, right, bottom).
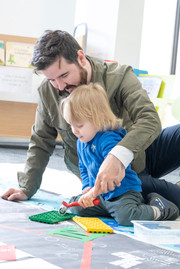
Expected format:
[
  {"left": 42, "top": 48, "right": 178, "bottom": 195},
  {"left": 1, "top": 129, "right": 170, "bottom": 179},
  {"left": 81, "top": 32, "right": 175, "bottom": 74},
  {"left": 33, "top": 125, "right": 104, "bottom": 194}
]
[{"left": 0, "top": 66, "right": 33, "bottom": 93}]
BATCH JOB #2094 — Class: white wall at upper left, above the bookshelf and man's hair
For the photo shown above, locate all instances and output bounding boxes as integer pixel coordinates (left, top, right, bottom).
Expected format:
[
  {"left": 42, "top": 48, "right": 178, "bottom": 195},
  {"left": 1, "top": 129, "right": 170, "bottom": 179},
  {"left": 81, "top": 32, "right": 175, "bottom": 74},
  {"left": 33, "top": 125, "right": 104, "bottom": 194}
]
[{"left": 0, "top": 0, "right": 76, "bottom": 38}]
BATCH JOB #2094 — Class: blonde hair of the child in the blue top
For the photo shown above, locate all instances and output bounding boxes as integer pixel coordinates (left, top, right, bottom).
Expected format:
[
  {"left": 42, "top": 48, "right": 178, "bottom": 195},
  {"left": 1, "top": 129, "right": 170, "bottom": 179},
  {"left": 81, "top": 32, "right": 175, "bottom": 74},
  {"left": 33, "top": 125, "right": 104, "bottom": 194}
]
[{"left": 60, "top": 83, "right": 121, "bottom": 131}]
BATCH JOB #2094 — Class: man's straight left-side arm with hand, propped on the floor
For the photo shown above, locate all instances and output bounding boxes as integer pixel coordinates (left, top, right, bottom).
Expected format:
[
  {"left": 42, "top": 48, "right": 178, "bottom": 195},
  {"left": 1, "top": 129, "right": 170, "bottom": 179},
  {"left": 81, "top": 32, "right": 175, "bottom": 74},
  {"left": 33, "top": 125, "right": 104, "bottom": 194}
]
[{"left": 1, "top": 85, "right": 57, "bottom": 200}]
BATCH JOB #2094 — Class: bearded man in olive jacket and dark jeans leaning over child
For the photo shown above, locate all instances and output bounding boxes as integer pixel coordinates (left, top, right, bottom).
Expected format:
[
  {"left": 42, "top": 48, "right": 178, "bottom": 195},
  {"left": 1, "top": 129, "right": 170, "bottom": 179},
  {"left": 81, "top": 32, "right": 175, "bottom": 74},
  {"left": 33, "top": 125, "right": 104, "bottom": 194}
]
[{"left": 2, "top": 30, "right": 180, "bottom": 209}]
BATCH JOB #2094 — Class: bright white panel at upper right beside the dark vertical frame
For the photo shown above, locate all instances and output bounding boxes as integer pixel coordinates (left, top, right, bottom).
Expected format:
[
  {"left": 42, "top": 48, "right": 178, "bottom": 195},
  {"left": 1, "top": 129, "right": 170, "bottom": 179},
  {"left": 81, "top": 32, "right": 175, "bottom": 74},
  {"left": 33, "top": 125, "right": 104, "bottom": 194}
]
[{"left": 139, "top": 0, "right": 177, "bottom": 75}]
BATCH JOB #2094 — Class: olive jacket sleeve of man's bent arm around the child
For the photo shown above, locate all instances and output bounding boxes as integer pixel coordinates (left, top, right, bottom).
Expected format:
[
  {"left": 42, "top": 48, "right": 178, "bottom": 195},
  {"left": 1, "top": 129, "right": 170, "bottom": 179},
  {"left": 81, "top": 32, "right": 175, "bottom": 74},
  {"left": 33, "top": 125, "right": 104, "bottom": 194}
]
[{"left": 115, "top": 67, "right": 161, "bottom": 159}]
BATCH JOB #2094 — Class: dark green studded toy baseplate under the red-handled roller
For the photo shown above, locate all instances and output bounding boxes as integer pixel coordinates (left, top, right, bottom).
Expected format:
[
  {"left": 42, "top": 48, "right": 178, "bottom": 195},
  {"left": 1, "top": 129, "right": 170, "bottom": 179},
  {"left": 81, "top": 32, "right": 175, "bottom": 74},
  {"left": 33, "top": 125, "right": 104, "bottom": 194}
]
[{"left": 29, "top": 210, "right": 75, "bottom": 224}]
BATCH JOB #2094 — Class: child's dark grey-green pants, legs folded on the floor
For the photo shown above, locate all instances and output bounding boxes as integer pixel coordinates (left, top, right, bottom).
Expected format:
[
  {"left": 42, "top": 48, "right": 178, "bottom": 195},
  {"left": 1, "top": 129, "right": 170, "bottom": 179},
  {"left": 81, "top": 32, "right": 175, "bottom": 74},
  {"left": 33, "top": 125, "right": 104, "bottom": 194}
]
[{"left": 69, "top": 190, "right": 154, "bottom": 226}]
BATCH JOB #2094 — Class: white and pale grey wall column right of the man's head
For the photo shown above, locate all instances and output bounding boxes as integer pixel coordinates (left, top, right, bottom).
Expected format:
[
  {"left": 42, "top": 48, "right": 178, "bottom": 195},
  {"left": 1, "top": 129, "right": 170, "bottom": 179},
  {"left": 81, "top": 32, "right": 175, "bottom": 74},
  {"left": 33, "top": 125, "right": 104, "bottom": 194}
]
[{"left": 76, "top": 0, "right": 144, "bottom": 68}]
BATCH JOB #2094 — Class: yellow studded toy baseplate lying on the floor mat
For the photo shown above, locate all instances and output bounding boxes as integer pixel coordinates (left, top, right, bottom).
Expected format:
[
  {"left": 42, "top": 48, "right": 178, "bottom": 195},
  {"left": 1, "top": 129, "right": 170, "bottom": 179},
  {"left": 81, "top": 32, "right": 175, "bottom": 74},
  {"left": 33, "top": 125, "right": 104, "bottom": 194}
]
[{"left": 72, "top": 217, "right": 114, "bottom": 233}]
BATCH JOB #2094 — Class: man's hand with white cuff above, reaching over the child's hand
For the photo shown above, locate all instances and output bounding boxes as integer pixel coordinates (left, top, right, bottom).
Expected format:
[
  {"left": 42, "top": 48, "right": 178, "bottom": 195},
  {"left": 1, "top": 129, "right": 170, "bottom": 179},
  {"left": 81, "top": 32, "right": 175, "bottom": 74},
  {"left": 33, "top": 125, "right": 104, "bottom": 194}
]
[{"left": 94, "top": 153, "right": 125, "bottom": 198}]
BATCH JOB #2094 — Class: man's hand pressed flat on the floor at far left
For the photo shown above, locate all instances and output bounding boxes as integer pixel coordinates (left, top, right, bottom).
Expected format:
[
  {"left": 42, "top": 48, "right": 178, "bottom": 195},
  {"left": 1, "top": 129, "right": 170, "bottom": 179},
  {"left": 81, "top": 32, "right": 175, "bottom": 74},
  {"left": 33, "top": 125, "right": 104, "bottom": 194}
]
[{"left": 1, "top": 188, "right": 28, "bottom": 201}]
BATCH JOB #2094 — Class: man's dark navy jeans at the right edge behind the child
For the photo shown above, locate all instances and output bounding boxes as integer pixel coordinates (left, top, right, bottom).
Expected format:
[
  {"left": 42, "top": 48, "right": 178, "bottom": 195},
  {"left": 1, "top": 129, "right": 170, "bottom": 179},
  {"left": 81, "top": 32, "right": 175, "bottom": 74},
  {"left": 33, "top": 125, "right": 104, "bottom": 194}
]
[{"left": 138, "top": 124, "right": 180, "bottom": 210}]
